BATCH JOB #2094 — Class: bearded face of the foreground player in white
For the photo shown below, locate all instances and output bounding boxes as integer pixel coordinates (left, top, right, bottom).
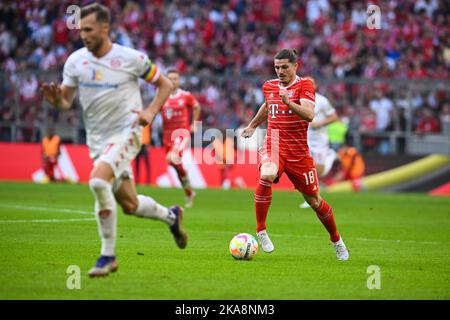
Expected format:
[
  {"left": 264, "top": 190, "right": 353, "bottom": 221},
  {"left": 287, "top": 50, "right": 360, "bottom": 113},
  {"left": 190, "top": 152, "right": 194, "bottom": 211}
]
[{"left": 80, "top": 13, "right": 109, "bottom": 52}]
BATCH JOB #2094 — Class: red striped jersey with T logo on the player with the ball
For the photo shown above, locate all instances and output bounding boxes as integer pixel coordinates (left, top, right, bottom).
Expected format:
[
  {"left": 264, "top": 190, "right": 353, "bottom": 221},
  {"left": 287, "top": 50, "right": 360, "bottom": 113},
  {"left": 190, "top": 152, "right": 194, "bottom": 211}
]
[{"left": 263, "top": 76, "right": 315, "bottom": 161}]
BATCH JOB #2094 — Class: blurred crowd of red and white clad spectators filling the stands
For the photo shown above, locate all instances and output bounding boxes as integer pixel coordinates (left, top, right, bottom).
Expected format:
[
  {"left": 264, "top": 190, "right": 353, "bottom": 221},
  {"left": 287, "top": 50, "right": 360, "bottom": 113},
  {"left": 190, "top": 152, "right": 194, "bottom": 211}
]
[{"left": 0, "top": 0, "right": 450, "bottom": 152}]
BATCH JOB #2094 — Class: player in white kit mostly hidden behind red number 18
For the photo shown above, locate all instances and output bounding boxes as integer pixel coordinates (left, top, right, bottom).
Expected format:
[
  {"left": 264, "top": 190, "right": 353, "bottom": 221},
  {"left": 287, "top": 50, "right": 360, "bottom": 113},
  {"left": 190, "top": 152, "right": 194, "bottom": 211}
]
[{"left": 300, "top": 77, "right": 338, "bottom": 209}]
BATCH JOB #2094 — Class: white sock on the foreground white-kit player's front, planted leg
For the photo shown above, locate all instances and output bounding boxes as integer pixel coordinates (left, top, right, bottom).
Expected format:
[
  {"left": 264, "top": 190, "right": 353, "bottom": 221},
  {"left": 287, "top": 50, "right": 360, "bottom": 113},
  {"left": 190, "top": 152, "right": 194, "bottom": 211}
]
[{"left": 89, "top": 178, "right": 117, "bottom": 256}]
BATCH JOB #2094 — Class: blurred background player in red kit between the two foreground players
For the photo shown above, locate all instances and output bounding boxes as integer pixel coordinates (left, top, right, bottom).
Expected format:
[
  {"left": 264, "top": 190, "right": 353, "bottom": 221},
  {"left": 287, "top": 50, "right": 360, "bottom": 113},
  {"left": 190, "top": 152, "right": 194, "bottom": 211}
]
[{"left": 161, "top": 69, "right": 201, "bottom": 208}]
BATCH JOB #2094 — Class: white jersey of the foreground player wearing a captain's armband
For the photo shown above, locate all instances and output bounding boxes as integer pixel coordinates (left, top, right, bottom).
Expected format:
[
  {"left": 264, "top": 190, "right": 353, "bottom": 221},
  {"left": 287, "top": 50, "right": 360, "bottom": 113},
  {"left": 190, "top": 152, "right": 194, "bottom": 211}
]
[{"left": 62, "top": 44, "right": 159, "bottom": 159}]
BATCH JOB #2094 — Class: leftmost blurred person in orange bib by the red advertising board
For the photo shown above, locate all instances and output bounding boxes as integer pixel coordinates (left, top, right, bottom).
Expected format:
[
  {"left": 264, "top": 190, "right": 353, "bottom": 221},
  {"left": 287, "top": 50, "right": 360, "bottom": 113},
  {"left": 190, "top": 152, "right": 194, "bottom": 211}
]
[{"left": 42, "top": 128, "right": 62, "bottom": 182}]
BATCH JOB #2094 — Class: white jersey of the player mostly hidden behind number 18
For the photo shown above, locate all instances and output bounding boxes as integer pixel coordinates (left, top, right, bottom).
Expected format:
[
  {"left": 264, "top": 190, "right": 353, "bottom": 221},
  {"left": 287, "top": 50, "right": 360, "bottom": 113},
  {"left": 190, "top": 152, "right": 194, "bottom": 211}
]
[{"left": 308, "top": 92, "right": 336, "bottom": 148}]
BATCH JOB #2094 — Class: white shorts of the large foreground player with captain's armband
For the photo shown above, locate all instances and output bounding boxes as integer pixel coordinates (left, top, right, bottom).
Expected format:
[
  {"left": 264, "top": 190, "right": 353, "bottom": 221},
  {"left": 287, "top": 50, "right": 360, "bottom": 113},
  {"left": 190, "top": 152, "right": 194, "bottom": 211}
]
[{"left": 94, "top": 130, "right": 141, "bottom": 180}]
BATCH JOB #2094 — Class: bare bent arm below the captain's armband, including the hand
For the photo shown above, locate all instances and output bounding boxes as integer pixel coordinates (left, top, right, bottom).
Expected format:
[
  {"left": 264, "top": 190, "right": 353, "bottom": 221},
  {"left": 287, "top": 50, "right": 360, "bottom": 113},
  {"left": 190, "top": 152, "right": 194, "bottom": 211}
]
[{"left": 133, "top": 74, "right": 173, "bottom": 126}]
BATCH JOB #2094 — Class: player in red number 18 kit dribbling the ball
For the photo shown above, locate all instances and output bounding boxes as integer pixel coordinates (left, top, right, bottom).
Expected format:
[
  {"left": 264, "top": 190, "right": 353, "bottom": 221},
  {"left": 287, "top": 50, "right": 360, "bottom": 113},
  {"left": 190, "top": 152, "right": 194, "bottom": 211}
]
[{"left": 242, "top": 49, "right": 349, "bottom": 260}]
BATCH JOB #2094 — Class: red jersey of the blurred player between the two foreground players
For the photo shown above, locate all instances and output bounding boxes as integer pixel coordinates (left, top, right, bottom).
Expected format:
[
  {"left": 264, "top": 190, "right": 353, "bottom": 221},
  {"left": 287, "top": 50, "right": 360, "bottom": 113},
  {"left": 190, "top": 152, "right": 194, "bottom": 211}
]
[{"left": 161, "top": 89, "right": 198, "bottom": 146}]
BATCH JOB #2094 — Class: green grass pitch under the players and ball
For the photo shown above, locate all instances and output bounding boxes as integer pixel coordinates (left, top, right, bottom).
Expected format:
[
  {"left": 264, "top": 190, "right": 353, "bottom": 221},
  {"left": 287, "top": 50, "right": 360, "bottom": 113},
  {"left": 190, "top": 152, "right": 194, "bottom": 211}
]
[{"left": 0, "top": 182, "right": 450, "bottom": 300}]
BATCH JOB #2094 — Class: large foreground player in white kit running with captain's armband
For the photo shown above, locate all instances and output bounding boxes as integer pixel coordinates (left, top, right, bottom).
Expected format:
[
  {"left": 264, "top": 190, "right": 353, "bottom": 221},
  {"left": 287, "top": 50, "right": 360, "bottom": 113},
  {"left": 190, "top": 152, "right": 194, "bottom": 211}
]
[{"left": 41, "top": 3, "right": 187, "bottom": 277}]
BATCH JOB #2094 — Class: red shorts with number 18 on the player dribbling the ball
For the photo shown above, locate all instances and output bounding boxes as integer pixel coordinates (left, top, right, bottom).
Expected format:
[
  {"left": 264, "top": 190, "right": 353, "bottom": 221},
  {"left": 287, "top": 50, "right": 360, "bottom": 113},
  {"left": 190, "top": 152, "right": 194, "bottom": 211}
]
[{"left": 258, "top": 156, "right": 319, "bottom": 195}]
